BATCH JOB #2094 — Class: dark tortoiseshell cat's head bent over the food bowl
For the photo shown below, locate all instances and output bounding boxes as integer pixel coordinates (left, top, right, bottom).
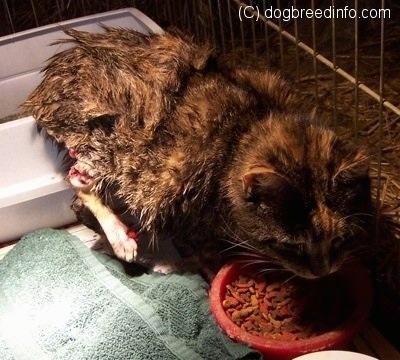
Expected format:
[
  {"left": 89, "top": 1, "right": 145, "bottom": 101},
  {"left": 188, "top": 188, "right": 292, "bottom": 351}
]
[{"left": 230, "top": 115, "right": 371, "bottom": 278}]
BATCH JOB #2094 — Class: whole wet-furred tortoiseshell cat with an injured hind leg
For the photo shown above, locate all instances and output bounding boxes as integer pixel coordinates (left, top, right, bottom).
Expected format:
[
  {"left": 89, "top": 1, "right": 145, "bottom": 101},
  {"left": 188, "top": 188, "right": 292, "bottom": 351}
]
[{"left": 25, "top": 28, "right": 370, "bottom": 278}]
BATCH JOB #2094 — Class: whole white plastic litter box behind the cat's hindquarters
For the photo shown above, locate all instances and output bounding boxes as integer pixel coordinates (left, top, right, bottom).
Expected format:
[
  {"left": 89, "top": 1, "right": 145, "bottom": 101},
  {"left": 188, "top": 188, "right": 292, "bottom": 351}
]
[{"left": 0, "top": 8, "right": 162, "bottom": 243}]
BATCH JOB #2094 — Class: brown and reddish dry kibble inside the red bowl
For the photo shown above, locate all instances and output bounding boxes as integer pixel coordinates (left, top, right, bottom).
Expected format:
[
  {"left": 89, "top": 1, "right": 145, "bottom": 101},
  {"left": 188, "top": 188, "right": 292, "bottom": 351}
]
[{"left": 222, "top": 275, "right": 351, "bottom": 341}]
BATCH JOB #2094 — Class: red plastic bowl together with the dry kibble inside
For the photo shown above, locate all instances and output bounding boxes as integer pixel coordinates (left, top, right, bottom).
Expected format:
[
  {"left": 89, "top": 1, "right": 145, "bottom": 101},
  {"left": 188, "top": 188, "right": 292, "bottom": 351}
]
[{"left": 210, "top": 263, "right": 372, "bottom": 359}]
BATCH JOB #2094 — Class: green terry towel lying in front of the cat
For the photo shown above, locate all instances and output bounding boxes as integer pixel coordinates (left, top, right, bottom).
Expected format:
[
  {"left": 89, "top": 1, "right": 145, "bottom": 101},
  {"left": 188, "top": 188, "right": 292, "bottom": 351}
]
[{"left": 0, "top": 229, "right": 261, "bottom": 360}]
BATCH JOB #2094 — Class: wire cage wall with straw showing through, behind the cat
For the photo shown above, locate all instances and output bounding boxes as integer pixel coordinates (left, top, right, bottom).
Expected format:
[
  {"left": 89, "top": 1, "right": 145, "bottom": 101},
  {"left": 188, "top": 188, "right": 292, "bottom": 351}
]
[{"left": 0, "top": 0, "right": 400, "bottom": 343}]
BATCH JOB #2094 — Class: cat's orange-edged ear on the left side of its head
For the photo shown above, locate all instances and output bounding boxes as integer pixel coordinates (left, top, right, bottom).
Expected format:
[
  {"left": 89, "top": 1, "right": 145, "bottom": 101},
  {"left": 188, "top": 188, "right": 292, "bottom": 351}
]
[{"left": 242, "top": 166, "right": 286, "bottom": 199}]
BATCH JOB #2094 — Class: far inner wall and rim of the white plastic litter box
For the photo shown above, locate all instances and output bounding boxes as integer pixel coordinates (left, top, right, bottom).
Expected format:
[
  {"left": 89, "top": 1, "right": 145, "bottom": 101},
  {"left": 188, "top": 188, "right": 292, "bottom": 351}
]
[{"left": 0, "top": 8, "right": 162, "bottom": 119}]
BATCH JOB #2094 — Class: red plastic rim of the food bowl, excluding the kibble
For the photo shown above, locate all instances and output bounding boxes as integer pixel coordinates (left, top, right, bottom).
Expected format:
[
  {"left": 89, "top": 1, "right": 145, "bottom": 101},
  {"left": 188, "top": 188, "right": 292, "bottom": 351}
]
[{"left": 210, "top": 262, "right": 373, "bottom": 360}]
